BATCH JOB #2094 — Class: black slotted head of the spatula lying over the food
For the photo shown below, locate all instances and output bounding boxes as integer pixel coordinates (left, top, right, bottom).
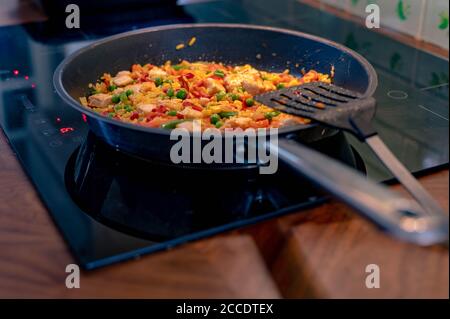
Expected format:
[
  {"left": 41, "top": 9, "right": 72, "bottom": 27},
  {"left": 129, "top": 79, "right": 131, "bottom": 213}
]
[{"left": 255, "top": 82, "right": 376, "bottom": 140}]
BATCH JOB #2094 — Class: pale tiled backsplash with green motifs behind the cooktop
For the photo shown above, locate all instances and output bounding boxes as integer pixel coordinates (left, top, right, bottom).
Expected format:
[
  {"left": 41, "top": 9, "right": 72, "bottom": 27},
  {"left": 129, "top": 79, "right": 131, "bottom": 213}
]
[{"left": 320, "top": 0, "right": 449, "bottom": 50}]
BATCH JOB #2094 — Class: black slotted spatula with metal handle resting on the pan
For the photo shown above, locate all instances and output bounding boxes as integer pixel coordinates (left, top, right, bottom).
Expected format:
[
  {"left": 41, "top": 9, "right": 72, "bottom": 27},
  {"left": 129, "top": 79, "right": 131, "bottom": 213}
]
[{"left": 255, "top": 82, "right": 445, "bottom": 220}]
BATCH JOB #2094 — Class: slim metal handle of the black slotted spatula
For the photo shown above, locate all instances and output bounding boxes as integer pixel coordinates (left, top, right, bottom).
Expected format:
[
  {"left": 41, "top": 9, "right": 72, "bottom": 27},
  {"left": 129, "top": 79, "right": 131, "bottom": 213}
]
[{"left": 365, "top": 135, "right": 445, "bottom": 215}]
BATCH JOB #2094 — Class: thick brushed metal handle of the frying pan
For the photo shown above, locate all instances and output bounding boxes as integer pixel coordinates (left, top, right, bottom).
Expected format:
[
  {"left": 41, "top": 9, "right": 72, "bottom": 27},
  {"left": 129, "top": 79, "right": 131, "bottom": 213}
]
[{"left": 268, "top": 138, "right": 448, "bottom": 246}]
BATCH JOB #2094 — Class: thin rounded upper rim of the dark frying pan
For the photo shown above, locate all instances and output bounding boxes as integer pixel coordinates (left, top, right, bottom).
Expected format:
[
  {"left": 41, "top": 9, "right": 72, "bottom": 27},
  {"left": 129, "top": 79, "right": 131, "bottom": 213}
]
[{"left": 53, "top": 23, "right": 378, "bottom": 136}]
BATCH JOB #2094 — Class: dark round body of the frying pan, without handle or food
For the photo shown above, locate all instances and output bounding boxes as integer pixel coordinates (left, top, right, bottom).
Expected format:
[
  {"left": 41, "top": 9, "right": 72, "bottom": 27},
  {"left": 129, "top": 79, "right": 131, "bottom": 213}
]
[{"left": 54, "top": 24, "right": 377, "bottom": 164}]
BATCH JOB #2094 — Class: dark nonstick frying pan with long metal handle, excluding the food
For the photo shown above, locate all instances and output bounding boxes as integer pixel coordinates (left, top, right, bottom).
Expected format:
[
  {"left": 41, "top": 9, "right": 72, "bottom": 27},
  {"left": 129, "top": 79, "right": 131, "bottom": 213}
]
[{"left": 54, "top": 24, "right": 447, "bottom": 244}]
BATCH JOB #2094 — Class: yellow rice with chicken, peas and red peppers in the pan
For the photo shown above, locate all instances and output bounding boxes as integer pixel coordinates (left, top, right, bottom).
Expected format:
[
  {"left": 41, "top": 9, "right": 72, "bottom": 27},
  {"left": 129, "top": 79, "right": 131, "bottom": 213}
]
[{"left": 80, "top": 61, "right": 331, "bottom": 130}]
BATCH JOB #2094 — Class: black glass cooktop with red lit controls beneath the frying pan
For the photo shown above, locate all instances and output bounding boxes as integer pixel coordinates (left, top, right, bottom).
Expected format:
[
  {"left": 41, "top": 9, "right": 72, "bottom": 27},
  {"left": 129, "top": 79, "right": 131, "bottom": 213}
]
[{"left": 0, "top": 1, "right": 449, "bottom": 269}]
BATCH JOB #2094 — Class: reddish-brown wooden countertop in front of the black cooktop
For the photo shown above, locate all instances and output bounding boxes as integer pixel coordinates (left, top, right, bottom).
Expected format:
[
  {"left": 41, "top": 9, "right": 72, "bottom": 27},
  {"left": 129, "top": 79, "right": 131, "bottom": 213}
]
[{"left": 0, "top": 128, "right": 449, "bottom": 298}]
